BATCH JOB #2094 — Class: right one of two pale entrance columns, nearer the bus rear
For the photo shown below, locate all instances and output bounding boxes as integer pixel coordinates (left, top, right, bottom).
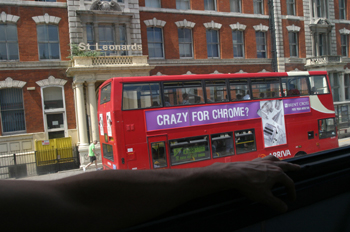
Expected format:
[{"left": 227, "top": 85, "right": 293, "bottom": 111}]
[{"left": 88, "top": 81, "right": 99, "bottom": 141}]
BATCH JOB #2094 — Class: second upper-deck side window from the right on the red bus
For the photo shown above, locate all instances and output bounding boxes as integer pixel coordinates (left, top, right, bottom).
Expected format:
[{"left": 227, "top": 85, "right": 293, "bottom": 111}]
[{"left": 282, "top": 76, "right": 309, "bottom": 97}]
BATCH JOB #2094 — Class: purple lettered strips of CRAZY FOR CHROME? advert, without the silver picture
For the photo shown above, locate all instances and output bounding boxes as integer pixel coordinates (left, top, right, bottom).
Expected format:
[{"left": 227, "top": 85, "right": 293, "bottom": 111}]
[{"left": 145, "top": 97, "right": 311, "bottom": 131}]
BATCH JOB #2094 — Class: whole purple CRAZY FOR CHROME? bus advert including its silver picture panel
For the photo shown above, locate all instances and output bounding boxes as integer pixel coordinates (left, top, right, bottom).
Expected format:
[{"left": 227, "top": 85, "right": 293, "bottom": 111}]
[{"left": 145, "top": 97, "right": 311, "bottom": 139}]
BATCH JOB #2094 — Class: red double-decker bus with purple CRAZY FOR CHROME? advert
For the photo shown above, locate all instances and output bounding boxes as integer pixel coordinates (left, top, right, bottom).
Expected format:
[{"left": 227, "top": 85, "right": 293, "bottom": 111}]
[{"left": 98, "top": 71, "right": 338, "bottom": 170}]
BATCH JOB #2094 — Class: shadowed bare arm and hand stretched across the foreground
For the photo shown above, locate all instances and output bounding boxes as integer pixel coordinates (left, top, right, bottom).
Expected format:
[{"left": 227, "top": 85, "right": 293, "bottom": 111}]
[{"left": 0, "top": 156, "right": 300, "bottom": 231}]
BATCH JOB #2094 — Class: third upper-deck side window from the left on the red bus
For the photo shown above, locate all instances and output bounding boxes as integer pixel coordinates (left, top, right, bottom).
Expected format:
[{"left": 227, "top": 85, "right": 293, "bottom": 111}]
[{"left": 205, "top": 80, "right": 228, "bottom": 103}]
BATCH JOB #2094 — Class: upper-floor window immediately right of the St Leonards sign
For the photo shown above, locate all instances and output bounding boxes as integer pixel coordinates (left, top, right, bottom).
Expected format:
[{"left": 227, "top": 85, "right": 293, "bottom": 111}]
[{"left": 147, "top": 27, "right": 164, "bottom": 58}]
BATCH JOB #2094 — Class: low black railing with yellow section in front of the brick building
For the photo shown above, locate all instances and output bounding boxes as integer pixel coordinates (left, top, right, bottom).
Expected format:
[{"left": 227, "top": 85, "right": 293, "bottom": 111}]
[{"left": 0, "top": 146, "right": 80, "bottom": 179}]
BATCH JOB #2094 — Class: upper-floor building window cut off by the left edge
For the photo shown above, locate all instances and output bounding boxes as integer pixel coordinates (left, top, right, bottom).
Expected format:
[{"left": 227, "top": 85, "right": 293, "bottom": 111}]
[{"left": 0, "top": 24, "right": 19, "bottom": 60}]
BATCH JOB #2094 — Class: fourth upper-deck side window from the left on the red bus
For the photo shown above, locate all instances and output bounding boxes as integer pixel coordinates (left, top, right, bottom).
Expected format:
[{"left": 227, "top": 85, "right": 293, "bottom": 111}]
[{"left": 230, "top": 79, "right": 251, "bottom": 101}]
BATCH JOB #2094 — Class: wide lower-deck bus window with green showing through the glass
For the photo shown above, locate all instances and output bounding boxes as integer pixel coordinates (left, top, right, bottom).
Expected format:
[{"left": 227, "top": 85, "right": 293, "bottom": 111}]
[{"left": 170, "top": 136, "right": 210, "bottom": 165}]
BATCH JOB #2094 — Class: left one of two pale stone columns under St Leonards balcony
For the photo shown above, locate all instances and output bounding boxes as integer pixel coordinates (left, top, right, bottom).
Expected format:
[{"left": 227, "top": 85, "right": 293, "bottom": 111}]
[{"left": 75, "top": 81, "right": 89, "bottom": 147}]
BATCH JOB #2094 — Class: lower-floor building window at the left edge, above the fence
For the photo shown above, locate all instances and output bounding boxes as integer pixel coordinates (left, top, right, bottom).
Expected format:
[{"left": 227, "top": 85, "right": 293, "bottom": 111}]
[{"left": 0, "top": 88, "right": 26, "bottom": 135}]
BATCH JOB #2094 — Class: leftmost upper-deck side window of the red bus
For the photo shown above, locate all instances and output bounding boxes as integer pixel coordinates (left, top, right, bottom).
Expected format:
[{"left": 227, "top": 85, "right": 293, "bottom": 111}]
[{"left": 123, "top": 83, "right": 162, "bottom": 110}]
